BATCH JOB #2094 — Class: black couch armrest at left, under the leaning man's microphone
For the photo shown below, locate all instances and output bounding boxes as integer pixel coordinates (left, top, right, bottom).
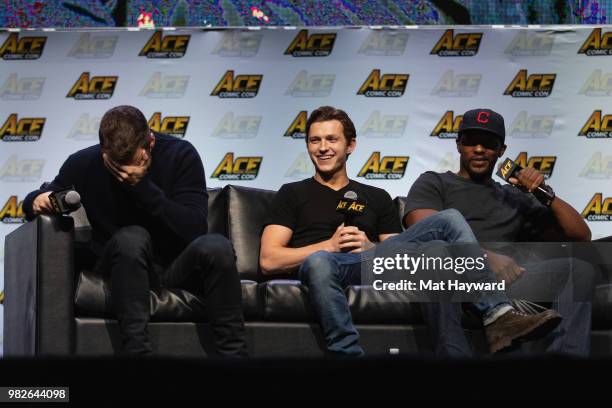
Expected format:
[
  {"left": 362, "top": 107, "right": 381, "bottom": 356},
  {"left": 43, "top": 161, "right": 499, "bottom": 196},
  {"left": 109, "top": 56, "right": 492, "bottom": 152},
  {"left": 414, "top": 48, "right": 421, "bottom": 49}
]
[{"left": 4, "top": 215, "right": 74, "bottom": 356}]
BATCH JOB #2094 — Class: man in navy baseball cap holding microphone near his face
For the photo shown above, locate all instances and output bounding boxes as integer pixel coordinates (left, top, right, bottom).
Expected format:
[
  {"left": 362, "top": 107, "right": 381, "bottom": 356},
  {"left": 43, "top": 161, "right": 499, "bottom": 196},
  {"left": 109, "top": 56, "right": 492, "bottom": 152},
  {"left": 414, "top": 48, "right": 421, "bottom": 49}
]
[{"left": 403, "top": 109, "right": 596, "bottom": 356}]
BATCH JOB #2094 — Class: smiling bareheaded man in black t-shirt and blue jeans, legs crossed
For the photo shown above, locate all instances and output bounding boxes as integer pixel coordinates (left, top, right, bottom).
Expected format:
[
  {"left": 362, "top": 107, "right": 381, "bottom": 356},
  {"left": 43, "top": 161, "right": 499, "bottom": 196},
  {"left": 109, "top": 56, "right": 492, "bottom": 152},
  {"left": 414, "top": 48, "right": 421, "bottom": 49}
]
[{"left": 260, "top": 106, "right": 559, "bottom": 356}]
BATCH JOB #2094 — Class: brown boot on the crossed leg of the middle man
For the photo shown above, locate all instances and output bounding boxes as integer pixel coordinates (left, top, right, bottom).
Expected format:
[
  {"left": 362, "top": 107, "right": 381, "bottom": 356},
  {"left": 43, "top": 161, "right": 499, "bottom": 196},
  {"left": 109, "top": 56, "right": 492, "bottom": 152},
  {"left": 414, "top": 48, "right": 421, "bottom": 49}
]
[{"left": 485, "top": 309, "right": 562, "bottom": 353}]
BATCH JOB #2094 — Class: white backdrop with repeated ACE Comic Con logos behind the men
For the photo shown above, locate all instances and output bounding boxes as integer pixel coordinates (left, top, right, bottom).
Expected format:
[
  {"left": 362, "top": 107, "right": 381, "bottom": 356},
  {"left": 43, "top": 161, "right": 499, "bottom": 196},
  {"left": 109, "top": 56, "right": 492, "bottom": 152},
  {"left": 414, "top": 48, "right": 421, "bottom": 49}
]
[{"left": 0, "top": 27, "right": 612, "bottom": 350}]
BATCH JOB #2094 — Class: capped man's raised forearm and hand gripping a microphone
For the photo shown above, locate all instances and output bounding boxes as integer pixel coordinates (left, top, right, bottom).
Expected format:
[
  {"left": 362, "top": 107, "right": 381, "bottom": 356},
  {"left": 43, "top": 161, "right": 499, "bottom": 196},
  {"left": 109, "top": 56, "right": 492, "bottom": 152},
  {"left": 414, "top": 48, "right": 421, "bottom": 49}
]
[{"left": 509, "top": 167, "right": 591, "bottom": 241}]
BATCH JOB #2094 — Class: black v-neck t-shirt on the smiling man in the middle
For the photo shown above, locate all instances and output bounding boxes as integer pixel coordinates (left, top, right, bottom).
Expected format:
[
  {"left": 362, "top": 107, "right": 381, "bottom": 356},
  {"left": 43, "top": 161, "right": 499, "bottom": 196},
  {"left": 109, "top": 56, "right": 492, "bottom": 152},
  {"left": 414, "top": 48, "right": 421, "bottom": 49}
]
[{"left": 265, "top": 178, "right": 402, "bottom": 248}]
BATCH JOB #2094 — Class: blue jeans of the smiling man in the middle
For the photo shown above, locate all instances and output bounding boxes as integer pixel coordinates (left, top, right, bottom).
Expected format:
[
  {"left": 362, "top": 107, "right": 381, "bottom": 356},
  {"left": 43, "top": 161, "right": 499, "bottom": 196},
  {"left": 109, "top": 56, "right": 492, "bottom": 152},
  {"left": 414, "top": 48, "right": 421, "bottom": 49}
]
[{"left": 298, "top": 209, "right": 509, "bottom": 356}]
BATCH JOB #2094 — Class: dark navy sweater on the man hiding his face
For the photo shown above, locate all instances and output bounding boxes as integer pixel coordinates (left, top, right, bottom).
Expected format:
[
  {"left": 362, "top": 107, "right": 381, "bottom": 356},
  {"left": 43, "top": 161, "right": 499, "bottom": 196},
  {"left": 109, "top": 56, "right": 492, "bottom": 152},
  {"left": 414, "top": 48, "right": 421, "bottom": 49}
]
[{"left": 23, "top": 133, "right": 208, "bottom": 261}]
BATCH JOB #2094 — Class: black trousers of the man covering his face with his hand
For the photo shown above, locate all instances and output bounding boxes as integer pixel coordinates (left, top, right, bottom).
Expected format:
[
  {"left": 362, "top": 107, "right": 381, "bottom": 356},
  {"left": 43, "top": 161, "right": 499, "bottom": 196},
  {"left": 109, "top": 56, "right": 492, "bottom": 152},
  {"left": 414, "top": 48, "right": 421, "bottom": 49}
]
[{"left": 96, "top": 226, "right": 247, "bottom": 356}]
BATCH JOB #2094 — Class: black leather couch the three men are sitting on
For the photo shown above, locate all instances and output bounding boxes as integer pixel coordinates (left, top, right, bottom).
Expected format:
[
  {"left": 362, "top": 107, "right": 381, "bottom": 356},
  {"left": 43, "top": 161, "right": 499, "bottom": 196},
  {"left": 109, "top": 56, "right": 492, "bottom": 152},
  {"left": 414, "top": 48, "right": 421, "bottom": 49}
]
[{"left": 4, "top": 185, "right": 612, "bottom": 357}]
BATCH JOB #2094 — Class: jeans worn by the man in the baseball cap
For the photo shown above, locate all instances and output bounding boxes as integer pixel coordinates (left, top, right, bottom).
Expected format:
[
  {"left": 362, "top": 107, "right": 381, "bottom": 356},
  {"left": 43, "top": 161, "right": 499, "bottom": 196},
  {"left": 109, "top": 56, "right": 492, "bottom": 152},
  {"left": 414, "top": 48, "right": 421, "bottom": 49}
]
[{"left": 421, "top": 258, "right": 597, "bottom": 357}]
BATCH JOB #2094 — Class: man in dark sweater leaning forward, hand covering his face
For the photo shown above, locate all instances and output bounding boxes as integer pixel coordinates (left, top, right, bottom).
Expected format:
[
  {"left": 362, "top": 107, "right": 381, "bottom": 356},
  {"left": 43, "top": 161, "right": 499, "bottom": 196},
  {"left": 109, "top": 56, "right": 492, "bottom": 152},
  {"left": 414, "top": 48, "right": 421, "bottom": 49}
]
[{"left": 23, "top": 106, "right": 246, "bottom": 356}]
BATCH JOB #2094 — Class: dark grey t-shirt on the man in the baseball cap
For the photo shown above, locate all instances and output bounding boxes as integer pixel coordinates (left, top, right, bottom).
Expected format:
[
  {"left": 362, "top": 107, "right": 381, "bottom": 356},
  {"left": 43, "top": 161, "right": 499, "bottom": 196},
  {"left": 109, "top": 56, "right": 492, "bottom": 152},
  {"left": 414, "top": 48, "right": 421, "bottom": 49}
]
[{"left": 406, "top": 171, "right": 549, "bottom": 242}]
